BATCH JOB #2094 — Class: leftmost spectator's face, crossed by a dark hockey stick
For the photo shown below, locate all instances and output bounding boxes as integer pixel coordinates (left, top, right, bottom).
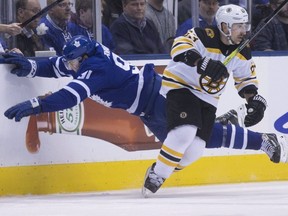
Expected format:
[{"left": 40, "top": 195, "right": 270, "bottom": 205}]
[{"left": 17, "top": 0, "right": 41, "bottom": 29}]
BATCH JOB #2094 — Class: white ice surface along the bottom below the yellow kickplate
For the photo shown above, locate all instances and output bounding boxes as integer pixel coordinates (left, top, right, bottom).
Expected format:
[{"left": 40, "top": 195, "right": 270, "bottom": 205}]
[{"left": 0, "top": 181, "right": 288, "bottom": 216}]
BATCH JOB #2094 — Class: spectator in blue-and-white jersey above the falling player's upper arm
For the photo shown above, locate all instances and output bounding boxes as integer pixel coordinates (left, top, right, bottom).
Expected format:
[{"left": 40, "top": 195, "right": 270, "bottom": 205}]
[{"left": 37, "top": 0, "right": 76, "bottom": 55}]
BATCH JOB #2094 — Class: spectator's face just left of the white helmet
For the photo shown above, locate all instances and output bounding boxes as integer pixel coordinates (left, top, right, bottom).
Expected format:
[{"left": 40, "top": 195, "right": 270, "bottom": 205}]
[{"left": 199, "top": 0, "right": 219, "bottom": 20}]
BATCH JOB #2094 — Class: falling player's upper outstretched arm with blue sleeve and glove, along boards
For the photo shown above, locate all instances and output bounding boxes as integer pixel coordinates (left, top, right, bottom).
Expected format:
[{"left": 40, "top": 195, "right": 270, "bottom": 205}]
[{"left": 0, "top": 52, "right": 73, "bottom": 78}]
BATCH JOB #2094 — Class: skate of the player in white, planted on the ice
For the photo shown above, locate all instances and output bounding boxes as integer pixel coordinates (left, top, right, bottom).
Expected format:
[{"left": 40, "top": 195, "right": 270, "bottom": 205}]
[{"left": 142, "top": 163, "right": 165, "bottom": 198}]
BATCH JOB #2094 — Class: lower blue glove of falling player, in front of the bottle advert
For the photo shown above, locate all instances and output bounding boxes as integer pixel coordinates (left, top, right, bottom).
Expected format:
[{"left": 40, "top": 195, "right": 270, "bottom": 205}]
[{"left": 4, "top": 98, "right": 41, "bottom": 122}]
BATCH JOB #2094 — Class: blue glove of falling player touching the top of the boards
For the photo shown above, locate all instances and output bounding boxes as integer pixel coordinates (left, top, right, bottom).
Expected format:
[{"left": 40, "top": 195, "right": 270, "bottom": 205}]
[{"left": 1, "top": 52, "right": 37, "bottom": 77}]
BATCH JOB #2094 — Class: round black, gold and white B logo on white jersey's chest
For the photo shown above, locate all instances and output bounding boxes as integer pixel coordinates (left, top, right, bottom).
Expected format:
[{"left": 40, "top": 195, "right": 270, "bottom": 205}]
[{"left": 199, "top": 76, "right": 228, "bottom": 94}]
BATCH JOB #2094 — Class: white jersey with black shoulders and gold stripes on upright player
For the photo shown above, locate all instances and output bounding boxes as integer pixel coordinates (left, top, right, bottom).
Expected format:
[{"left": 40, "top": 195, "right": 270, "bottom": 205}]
[{"left": 160, "top": 27, "right": 258, "bottom": 107}]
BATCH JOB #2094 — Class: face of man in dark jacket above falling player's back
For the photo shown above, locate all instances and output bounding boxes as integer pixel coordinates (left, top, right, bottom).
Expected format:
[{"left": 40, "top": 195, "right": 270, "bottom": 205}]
[{"left": 123, "top": 0, "right": 146, "bottom": 20}]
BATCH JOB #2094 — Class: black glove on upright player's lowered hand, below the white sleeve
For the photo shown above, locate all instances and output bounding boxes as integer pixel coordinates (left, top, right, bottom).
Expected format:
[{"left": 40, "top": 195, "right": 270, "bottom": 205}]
[{"left": 244, "top": 94, "right": 267, "bottom": 127}]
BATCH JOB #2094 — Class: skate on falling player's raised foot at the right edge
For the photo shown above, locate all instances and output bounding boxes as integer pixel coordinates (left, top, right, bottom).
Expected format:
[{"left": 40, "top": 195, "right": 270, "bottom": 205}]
[{"left": 261, "top": 134, "right": 288, "bottom": 163}]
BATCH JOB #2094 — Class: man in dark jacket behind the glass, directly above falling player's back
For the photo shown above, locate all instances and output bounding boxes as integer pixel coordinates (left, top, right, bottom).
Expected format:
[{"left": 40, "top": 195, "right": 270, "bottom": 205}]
[{"left": 110, "top": 0, "right": 167, "bottom": 54}]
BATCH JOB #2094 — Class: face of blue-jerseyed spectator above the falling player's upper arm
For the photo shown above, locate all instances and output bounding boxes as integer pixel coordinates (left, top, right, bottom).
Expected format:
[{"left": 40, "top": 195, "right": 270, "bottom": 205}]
[{"left": 48, "top": 0, "right": 73, "bottom": 23}]
